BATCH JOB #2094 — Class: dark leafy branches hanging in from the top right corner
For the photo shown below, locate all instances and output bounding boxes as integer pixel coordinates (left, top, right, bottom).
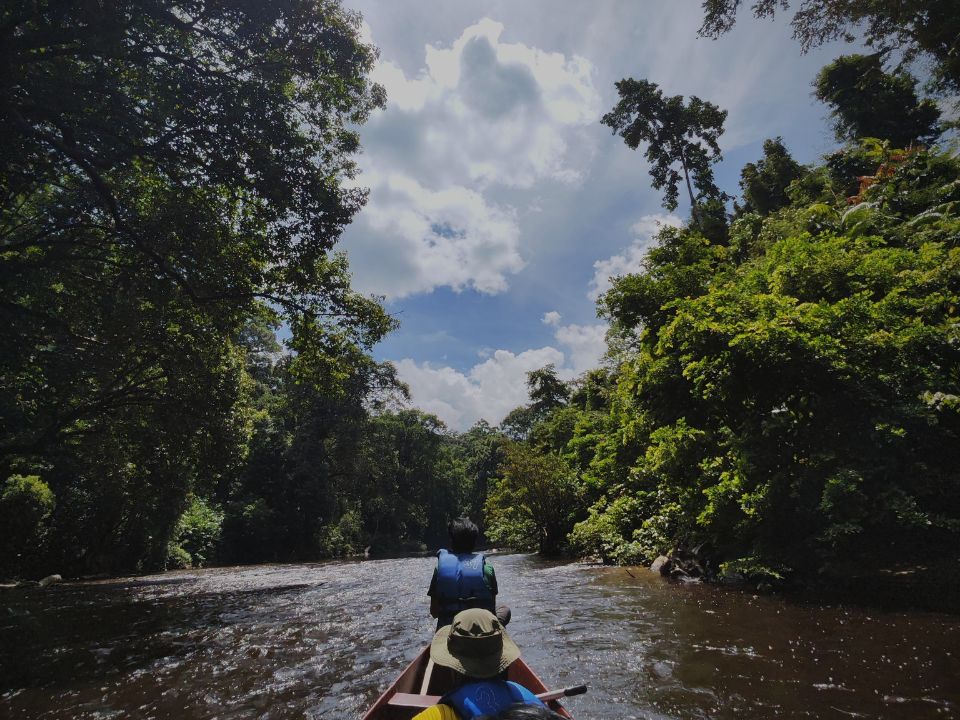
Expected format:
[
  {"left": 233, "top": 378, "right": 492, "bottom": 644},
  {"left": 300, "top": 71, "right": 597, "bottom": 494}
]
[{"left": 700, "top": 0, "right": 960, "bottom": 93}]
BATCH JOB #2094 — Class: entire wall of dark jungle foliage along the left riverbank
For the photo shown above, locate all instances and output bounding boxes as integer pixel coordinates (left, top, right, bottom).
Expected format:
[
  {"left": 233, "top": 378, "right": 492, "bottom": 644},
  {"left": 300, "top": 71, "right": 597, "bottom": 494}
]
[{"left": 0, "top": 0, "right": 480, "bottom": 577}]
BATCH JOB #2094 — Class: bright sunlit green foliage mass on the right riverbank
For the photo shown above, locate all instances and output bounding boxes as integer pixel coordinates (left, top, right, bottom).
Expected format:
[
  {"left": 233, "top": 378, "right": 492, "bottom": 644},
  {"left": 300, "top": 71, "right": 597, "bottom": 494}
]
[{"left": 571, "top": 147, "right": 960, "bottom": 577}]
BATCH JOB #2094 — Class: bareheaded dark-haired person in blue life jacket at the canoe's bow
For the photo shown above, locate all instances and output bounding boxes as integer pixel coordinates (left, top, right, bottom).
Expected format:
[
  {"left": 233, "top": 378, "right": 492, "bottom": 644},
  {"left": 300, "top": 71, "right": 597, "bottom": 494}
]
[{"left": 427, "top": 517, "right": 510, "bottom": 630}]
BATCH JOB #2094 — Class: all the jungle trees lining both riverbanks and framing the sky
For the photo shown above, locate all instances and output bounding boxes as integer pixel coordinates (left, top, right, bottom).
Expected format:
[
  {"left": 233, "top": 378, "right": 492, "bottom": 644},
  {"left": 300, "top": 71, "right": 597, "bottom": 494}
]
[{"left": 0, "top": 0, "right": 960, "bottom": 579}]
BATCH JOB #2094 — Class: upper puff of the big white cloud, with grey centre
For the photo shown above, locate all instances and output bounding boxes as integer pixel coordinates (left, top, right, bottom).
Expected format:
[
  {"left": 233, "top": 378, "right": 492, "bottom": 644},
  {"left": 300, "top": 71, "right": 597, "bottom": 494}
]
[{"left": 364, "top": 18, "right": 600, "bottom": 187}]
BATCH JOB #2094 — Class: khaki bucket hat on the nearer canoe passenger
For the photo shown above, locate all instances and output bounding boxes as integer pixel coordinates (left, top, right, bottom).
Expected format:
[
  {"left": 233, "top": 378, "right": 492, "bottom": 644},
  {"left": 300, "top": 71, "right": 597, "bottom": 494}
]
[{"left": 430, "top": 608, "right": 520, "bottom": 678}]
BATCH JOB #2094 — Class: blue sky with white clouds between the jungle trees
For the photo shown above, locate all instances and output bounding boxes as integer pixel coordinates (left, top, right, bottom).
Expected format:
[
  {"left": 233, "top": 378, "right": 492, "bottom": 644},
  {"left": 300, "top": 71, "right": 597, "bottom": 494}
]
[{"left": 341, "top": 0, "right": 855, "bottom": 431}]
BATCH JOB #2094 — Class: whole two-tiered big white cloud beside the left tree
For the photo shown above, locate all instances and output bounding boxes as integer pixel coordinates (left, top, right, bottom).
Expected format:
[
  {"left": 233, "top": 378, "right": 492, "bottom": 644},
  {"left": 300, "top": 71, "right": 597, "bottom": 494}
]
[{"left": 344, "top": 19, "right": 600, "bottom": 298}]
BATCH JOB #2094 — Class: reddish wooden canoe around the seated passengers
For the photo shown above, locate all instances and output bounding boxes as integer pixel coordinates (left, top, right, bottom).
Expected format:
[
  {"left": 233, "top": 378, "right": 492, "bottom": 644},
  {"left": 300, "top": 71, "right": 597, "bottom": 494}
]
[{"left": 363, "top": 645, "right": 572, "bottom": 720}]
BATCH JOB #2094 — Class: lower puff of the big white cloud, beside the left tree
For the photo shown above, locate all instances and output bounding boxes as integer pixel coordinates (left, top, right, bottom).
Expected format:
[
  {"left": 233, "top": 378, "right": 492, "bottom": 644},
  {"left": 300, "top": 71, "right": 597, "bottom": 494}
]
[{"left": 350, "top": 173, "right": 524, "bottom": 298}]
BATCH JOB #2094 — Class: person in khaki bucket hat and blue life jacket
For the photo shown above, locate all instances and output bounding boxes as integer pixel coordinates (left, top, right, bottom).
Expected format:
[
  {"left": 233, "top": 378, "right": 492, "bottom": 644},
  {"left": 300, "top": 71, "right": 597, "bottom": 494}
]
[{"left": 413, "top": 608, "right": 543, "bottom": 720}]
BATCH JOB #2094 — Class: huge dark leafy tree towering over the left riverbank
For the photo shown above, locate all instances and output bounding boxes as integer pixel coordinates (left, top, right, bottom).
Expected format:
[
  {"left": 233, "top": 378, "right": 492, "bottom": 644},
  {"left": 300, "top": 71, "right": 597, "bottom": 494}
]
[{"left": 0, "top": 0, "right": 393, "bottom": 572}]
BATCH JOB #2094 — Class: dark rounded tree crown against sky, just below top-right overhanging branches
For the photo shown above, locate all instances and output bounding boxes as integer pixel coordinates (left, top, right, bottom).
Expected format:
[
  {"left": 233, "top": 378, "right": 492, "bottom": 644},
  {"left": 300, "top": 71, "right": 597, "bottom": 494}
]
[{"left": 813, "top": 54, "right": 940, "bottom": 148}]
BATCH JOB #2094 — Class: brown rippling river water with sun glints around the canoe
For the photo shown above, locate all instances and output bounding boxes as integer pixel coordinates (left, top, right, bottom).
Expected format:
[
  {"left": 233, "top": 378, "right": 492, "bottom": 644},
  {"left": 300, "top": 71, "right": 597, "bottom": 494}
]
[{"left": 0, "top": 555, "right": 960, "bottom": 720}]
